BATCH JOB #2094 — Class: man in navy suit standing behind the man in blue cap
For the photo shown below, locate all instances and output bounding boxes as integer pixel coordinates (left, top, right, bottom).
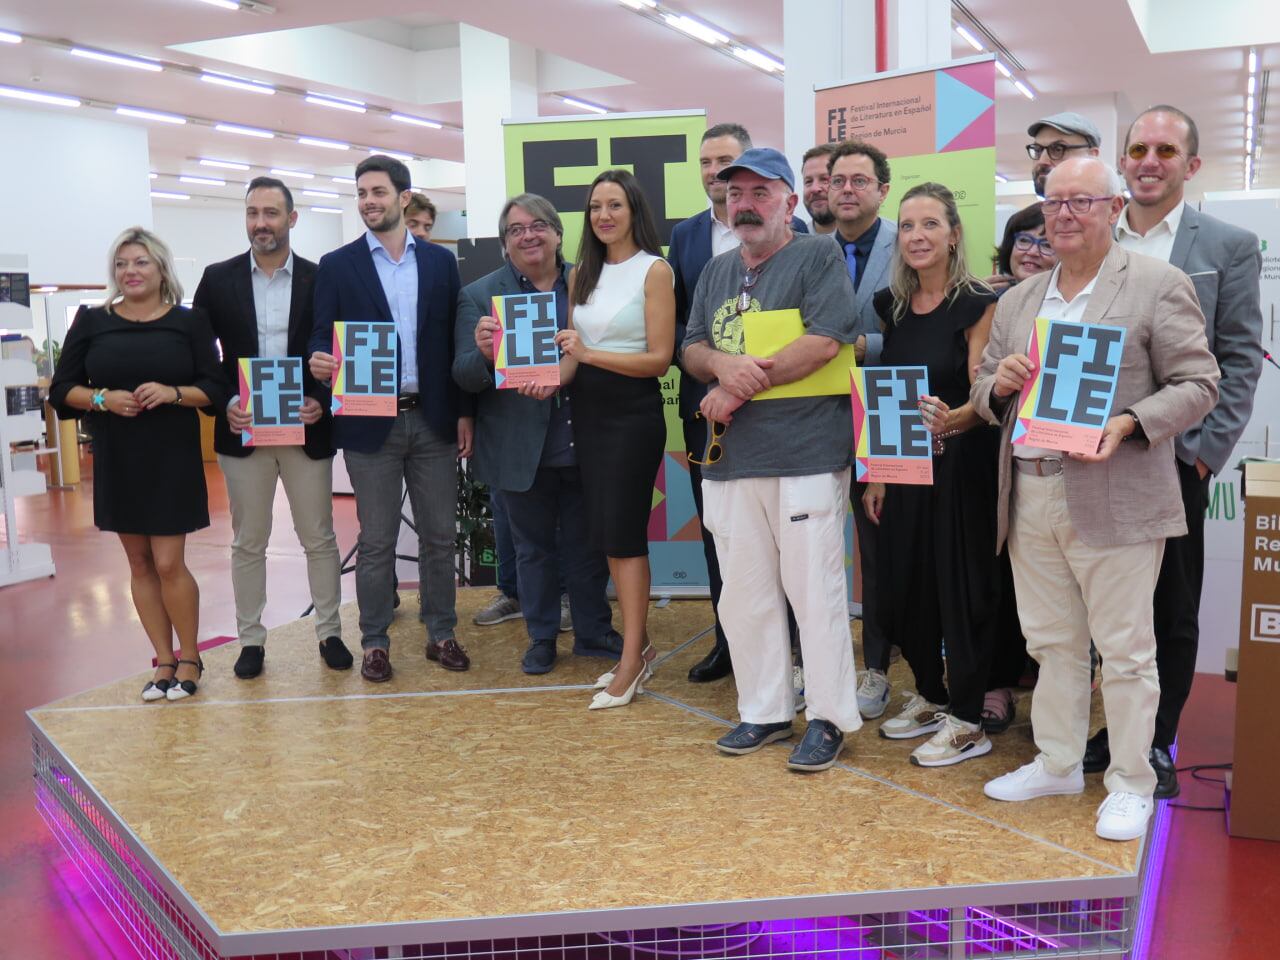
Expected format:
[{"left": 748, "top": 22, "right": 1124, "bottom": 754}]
[{"left": 667, "top": 123, "right": 809, "bottom": 684}]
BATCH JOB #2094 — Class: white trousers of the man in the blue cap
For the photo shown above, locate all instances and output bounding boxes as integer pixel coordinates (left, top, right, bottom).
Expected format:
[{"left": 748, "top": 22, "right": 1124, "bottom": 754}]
[{"left": 703, "top": 470, "right": 863, "bottom": 733}]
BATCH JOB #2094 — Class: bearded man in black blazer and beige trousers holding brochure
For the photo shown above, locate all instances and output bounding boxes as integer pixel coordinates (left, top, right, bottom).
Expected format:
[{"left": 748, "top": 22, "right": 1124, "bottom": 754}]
[{"left": 195, "top": 177, "right": 352, "bottom": 680}]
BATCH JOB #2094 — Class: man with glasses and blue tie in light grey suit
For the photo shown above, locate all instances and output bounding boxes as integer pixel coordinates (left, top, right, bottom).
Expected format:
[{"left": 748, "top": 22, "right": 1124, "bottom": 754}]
[{"left": 827, "top": 140, "right": 897, "bottom": 719}]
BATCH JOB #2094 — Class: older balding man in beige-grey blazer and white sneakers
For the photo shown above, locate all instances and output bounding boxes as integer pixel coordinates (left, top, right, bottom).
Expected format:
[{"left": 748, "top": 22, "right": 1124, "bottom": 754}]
[{"left": 970, "top": 157, "right": 1219, "bottom": 840}]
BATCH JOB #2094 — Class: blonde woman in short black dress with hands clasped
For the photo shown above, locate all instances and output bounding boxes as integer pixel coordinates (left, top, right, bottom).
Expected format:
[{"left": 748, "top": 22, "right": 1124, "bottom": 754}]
[{"left": 49, "top": 227, "right": 227, "bottom": 700}]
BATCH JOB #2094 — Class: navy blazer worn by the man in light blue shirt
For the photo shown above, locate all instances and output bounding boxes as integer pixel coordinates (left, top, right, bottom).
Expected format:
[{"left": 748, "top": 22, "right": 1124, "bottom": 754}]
[{"left": 307, "top": 233, "right": 475, "bottom": 453}]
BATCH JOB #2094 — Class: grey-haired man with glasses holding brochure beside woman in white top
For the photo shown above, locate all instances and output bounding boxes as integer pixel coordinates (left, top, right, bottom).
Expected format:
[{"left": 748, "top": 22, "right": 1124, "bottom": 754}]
[{"left": 453, "top": 193, "right": 622, "bottom": 673}]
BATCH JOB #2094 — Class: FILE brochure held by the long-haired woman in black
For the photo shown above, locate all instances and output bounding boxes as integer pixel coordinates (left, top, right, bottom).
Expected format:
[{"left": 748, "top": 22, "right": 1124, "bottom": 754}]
[{"left": 849, "top": 366, "right": 933, "bottom": 485}]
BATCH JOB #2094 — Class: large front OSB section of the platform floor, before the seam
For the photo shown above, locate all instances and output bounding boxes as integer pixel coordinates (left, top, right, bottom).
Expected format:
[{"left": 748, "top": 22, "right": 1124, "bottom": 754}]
[{"left": 37, "top": 690, "right": 1115, "bottom": 933}]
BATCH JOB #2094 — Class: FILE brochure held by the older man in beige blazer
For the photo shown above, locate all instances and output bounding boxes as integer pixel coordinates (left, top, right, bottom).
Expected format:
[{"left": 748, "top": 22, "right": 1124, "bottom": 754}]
[{"left": 1012, "top": 316, "right": 1125, "bottom": 453}]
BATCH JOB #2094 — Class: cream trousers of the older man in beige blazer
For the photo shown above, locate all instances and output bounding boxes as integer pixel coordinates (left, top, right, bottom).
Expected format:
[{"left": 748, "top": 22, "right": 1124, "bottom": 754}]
[{"left": 1009, "top": 471, "right": 1165, "bottom": 797}]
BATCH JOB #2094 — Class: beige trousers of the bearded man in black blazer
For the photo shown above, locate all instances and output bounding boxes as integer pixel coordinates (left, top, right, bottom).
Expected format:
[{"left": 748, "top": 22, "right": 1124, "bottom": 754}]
[{"left": 218, "top": 447, "right": 342, "bottom": 646}]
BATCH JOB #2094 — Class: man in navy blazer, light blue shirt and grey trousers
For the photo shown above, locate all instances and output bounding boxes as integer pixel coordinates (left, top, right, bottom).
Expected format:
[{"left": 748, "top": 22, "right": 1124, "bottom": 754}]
[{"left": 310, "top": 155, "right": 472, "bottom": 682}]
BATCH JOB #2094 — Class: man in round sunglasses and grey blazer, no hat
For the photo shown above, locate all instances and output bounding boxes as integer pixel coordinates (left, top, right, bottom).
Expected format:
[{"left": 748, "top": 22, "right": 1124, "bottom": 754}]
[{"left": 1084, "top": 105, "right": 1262, "bottom": 799}]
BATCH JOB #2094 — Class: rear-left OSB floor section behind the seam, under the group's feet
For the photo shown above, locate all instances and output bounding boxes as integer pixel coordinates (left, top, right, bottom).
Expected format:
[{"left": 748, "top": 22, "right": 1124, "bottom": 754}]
[{"left": 40, "top": 588, "right": 713, "bottom": 708}]
